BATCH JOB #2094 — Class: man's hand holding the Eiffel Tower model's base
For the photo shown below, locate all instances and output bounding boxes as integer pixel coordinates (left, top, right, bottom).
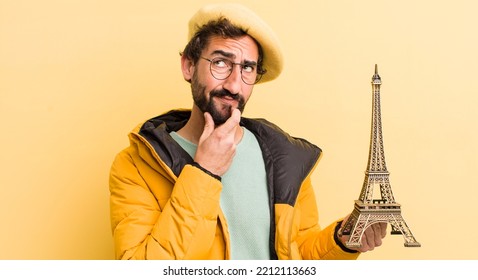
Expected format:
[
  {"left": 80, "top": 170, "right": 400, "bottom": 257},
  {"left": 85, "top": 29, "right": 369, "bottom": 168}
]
[{"left": 339, "top": 215, "right": 387, "bottom": 253}]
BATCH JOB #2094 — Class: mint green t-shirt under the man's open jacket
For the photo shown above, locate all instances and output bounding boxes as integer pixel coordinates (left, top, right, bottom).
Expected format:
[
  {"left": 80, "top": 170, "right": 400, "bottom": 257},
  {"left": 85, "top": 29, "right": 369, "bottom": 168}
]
[{"left": 171, "top": 128, "right": 271, "bottom": 260}]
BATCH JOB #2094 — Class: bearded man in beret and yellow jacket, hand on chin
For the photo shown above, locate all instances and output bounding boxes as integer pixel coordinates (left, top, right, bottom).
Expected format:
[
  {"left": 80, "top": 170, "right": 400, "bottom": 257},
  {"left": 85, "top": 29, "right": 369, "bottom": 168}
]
[{"left": 110, "top": 4, "right": 386, "bottom": 260}]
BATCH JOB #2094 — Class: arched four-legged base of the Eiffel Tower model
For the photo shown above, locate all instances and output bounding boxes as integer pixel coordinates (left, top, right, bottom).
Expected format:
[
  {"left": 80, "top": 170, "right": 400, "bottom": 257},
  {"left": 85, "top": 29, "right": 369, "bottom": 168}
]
[{"left": 339, "top": 201, "right": 421, "bottom": 248}]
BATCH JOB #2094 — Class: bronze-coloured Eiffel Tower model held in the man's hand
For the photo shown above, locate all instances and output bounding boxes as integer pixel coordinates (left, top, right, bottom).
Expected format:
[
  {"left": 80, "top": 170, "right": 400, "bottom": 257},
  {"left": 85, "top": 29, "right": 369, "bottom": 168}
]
[{"left": 339, "top": 64, "right": 421, "bottom": 248}]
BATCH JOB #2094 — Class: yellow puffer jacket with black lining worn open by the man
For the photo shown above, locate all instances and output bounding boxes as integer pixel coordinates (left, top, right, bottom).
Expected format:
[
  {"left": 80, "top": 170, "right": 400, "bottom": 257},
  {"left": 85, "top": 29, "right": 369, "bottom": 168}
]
[{"left": 110, "top": 110, "right": 358, "bottom": 260}]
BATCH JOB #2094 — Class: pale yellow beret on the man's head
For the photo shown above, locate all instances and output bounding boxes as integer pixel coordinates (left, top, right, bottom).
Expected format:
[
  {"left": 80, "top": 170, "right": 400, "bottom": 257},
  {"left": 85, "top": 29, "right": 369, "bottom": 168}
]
[{"left": 188, "top": 3, "right": 284, "bottom": 83}]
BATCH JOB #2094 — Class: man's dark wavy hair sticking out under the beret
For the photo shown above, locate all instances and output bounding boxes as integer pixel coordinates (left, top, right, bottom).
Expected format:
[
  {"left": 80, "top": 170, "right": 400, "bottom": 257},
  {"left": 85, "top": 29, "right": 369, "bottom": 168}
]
[{"left": 182, "top": 17, "right": 265, "bottom": 74}]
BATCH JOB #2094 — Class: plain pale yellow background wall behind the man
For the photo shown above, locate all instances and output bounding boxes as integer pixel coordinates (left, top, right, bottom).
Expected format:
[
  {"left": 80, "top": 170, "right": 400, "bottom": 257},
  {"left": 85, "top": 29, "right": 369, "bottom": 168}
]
[{"left": 0, "top": 0, "right": 478, "bottom": 259}]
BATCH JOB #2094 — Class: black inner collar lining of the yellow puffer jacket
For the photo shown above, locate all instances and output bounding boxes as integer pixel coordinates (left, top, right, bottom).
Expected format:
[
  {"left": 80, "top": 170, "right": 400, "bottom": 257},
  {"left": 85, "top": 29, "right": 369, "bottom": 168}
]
[{"left": 135, "top": 110, "right": 321, "bottom": 206}]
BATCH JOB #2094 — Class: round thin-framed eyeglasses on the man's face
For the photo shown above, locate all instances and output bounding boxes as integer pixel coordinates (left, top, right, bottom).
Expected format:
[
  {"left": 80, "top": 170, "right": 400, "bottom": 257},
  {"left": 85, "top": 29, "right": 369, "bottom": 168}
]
[{"left": 201, "top": 57, "right": 264, "bottom": 85}]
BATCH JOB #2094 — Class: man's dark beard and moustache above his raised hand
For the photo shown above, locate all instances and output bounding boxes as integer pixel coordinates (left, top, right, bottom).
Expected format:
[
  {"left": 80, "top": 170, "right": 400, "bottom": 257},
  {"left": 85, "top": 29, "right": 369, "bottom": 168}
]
[{"left": 191, "top": 72, "right": 246, "bottom": 126}]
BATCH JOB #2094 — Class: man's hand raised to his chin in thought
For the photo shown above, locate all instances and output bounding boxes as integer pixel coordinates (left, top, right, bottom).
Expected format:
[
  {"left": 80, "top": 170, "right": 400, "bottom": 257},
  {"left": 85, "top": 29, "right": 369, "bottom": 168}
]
[{"left": 194, "top": 109, "right": 241, "bottom": 176}]
